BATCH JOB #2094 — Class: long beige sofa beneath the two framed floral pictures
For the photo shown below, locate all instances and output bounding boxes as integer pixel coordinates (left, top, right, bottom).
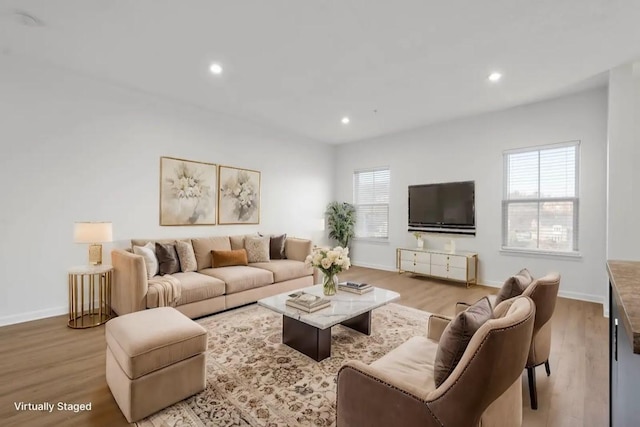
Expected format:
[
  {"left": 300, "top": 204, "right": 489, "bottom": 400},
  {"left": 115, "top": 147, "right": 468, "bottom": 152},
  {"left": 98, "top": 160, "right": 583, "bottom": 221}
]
[{"left": 111, "top": 236, "right": 314, "bottom": 318}]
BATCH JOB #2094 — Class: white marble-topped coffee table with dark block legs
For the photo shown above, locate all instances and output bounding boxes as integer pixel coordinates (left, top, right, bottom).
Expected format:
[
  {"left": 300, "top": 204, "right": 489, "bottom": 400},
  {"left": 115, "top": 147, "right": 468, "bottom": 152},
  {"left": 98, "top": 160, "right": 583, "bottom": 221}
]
[{"left": 258, "top": 285, "right": 400, "bottom": 362}]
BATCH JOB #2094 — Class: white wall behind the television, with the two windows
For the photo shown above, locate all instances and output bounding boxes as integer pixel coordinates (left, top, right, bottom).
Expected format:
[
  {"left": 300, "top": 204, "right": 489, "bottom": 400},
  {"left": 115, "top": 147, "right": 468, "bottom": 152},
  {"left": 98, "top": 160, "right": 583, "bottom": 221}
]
[{"left": 335, "top": 88, "right": 607, "bottom": 302}]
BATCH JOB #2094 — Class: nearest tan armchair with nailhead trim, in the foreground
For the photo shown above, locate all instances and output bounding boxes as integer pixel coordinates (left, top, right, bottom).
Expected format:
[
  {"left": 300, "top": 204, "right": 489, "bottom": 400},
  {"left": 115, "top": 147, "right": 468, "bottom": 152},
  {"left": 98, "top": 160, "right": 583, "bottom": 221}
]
[{"left": 336, "top": 297, "right": 535, "bottom": 427}]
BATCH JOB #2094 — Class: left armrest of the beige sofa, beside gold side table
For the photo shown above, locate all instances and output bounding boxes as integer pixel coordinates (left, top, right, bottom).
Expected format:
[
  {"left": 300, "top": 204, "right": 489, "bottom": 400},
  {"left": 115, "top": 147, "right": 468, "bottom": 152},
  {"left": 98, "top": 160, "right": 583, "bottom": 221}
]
[{"left": 111, "top": 249, "right": 149, "bottom": 316}]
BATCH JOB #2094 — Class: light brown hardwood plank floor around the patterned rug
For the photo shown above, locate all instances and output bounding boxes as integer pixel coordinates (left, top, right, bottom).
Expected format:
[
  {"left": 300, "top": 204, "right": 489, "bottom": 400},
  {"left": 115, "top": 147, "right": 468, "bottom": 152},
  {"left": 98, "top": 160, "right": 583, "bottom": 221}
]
[{"left": 0, "top": 267, "right": 609, "bottom": 427}]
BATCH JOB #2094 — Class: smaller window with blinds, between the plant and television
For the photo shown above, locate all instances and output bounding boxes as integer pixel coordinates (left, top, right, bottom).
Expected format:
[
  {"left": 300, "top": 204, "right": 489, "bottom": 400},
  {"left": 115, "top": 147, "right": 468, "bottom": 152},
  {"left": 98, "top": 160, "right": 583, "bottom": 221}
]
[{"left": 353, "top": 167, "right": 391, "bottom": 240}]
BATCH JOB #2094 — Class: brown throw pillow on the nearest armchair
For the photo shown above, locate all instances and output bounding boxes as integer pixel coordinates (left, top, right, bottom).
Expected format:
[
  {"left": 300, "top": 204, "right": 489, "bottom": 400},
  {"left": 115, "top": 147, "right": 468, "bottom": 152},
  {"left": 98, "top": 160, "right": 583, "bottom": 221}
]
[{"left": 433, "top": 297, "right": 493, "bottom": 387}]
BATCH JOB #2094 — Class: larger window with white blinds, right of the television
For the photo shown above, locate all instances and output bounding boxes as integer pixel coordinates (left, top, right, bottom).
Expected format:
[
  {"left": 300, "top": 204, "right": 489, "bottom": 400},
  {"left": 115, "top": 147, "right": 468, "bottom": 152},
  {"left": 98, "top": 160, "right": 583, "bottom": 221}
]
[{"left": 502, "top": 141, "right": 580, "bottom": 252}]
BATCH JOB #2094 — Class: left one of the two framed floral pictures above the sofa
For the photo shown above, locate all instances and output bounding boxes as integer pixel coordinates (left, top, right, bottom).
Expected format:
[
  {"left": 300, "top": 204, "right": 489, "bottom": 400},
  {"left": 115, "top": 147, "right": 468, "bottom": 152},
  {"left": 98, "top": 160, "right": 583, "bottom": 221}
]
[{"left": 160, "top": 157, "right": 218, "bottom": 225}]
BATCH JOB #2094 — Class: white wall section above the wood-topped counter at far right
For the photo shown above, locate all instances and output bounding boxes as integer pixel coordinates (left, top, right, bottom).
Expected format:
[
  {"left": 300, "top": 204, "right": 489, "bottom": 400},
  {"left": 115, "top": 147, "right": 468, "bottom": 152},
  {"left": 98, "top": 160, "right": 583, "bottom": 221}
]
[{"left": 607, "top": 61, "right": 640, "bottom": 260}]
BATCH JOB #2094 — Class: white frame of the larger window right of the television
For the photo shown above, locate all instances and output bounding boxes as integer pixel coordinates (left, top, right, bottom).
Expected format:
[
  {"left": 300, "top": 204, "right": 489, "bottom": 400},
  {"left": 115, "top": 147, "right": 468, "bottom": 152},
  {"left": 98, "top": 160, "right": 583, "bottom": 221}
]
[{"left": 501, "top": 140, "right": 580, "bottom": 257}]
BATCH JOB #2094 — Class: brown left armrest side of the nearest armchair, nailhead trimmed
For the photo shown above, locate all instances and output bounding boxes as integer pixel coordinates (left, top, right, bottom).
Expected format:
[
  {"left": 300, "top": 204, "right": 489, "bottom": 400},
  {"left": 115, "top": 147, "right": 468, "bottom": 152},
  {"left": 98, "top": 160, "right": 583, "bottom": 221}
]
[{"left": 336, "top": 361, "right": 440, "bottom": 427}]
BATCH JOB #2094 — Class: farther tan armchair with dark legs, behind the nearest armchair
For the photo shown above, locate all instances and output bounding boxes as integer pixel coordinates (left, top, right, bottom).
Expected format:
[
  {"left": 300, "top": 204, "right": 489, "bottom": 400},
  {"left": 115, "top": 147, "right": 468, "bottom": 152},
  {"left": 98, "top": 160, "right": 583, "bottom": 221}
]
[{"left": 456, "top": 272, "right": 560, "bottom": 409}]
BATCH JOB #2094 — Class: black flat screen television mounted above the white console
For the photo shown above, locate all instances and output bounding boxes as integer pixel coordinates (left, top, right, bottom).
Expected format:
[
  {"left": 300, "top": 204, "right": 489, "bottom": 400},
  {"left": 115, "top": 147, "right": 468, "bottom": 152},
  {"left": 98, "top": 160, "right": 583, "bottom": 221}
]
[{"left": 409, "top": 181, "right": 476, "bottom": 234}]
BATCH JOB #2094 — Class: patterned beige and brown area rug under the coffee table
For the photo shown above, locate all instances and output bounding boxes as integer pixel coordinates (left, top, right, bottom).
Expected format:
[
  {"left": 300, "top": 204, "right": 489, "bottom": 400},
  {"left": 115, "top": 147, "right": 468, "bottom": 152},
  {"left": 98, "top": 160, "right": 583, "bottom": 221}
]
[{"left": 137, "top": 304, "right": 429, "bottom": 427}]
